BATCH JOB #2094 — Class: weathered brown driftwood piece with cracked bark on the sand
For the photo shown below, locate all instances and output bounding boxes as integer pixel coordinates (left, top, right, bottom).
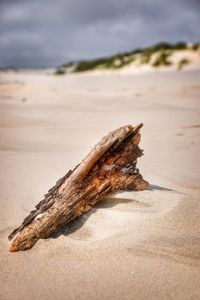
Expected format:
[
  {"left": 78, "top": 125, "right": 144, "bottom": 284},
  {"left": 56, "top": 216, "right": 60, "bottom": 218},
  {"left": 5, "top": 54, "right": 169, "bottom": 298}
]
[{"left": 9, "top": 124, "right": 148, "bottom": 252}]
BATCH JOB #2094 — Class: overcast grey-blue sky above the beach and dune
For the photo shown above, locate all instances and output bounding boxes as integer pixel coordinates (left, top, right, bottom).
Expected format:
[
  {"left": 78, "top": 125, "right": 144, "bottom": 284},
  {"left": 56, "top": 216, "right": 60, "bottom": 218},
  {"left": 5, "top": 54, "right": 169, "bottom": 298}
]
[{"left": 0, "top": 0, "right": 200, "bottom": 68}]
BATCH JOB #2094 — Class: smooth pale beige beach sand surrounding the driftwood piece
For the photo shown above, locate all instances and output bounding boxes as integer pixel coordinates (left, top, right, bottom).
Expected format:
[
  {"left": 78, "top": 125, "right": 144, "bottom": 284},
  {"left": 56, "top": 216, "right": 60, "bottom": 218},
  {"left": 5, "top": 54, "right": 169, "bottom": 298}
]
[{"left": 0, "top": 71, "right": 200, "bottom": 300}]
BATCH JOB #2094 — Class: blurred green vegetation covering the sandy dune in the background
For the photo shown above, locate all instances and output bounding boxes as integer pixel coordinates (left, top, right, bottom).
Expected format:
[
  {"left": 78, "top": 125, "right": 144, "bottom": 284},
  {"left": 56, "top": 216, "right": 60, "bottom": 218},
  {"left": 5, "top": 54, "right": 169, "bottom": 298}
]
[{"left": 55, "top": 42, "right": 200, "bottom": 75}]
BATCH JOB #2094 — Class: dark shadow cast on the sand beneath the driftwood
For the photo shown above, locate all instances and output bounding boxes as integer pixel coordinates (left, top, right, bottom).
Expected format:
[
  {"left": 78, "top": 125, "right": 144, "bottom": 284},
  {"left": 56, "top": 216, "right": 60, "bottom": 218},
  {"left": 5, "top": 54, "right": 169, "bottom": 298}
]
[{"left": 50, "top": 184, "right": 182, "bottom": 238}]
